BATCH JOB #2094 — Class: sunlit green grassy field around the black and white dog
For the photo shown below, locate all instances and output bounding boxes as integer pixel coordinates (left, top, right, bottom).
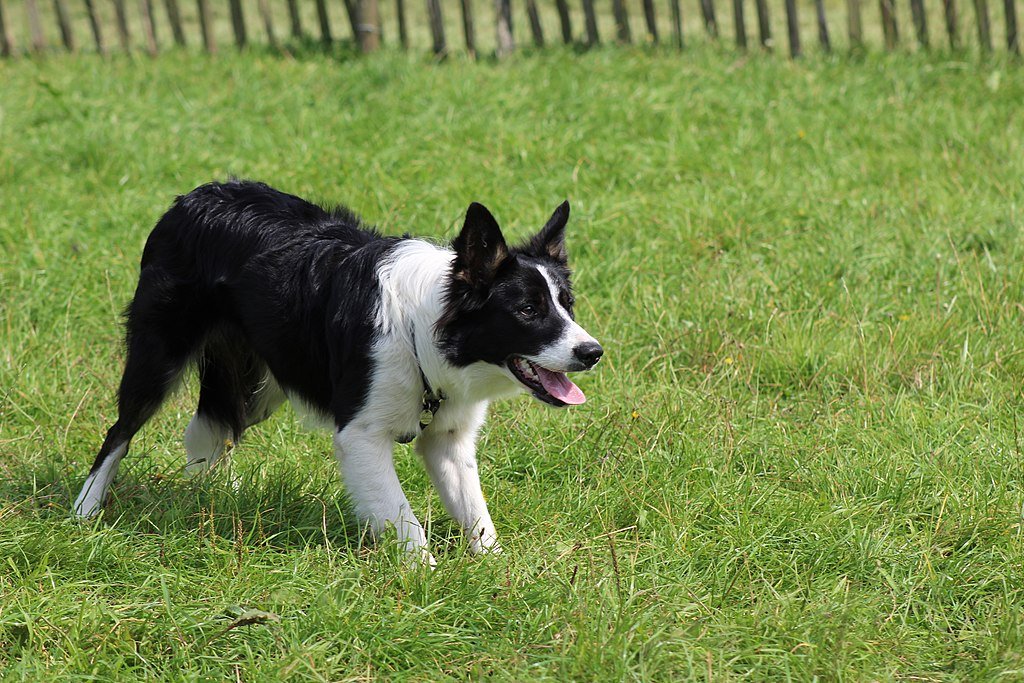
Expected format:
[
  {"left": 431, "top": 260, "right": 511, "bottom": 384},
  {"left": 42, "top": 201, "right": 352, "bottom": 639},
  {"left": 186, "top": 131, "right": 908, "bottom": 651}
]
[{"left": 0, "top": 48, "right": 1024, "bottom": 681}]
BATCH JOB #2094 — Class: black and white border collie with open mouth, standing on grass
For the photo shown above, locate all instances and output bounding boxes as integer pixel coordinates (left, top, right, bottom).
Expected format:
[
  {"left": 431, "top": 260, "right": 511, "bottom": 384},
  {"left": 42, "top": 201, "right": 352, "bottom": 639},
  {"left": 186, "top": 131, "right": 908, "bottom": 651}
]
[{"left": 75, "top": 181, "right": 602, "bottom": 564}]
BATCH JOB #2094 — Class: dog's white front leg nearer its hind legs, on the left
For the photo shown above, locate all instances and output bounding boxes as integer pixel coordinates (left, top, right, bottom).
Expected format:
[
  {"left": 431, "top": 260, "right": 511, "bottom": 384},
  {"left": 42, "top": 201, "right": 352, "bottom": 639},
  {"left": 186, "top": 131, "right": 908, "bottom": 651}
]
[{"left": 334, "top": 425, "right": 435, "bottom": 566}]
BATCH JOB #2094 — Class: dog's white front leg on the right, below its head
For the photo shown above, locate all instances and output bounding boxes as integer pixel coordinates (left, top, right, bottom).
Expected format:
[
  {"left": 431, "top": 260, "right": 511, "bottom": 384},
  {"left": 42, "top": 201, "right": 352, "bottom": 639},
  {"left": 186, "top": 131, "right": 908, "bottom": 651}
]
[{"left": 416, "top": 428, "right": 501, "bottom": 554}]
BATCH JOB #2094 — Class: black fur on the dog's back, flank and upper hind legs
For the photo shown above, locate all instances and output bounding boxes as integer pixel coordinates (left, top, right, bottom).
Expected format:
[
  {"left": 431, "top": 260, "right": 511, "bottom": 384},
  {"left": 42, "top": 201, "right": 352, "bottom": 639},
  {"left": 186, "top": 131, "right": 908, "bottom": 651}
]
[{"left": 112, "top": 181, "right": 396, "bottom": 448}]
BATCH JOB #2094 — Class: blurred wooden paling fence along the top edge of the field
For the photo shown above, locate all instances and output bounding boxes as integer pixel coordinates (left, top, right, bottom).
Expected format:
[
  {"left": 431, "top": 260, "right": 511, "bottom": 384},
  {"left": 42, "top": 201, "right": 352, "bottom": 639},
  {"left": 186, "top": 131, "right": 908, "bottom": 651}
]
[{"left": 0, "top": 0, "right": 1020, "bottom": 58}]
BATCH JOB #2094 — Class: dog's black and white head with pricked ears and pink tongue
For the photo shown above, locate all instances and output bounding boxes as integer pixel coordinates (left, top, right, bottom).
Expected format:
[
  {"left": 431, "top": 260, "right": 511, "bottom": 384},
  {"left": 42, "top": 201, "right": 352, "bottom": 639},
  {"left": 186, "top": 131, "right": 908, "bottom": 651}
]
[{"left": 437, "top": 202, "right": 603, "bottom": 407}]
